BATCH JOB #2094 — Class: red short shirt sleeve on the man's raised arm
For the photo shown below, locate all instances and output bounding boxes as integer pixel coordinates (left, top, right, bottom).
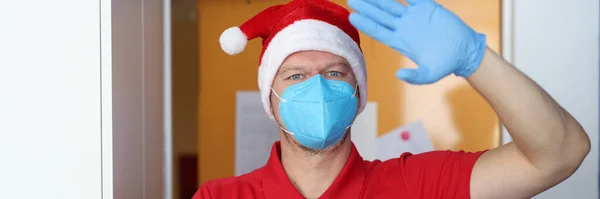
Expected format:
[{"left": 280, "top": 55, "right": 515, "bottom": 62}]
[{"left": 395, "top": 151, "right": 485, "bottom": 199}]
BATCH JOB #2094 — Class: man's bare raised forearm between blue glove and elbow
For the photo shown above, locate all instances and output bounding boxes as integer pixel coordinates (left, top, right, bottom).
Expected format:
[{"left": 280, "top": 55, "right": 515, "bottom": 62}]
[{"left": 467, "top": 49, "right": 590, "bottom": 170}]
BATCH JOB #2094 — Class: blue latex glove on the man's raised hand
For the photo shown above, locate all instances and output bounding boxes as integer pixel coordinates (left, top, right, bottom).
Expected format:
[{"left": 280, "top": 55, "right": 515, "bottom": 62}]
[{"left": 348, "top": 0, "right": 486, "bottom": 84}]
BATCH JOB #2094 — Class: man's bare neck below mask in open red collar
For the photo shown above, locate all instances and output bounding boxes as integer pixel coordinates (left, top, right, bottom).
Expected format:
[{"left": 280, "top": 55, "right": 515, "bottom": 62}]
[{"left": 281, "top": 134, "right": 352, "bottom": 198}]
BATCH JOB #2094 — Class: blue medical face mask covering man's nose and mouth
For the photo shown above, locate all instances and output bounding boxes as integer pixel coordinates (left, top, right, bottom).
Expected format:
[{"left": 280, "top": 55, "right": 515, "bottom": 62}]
[{"left": 273, "top": 75, "right": 358, "bottom": 149}]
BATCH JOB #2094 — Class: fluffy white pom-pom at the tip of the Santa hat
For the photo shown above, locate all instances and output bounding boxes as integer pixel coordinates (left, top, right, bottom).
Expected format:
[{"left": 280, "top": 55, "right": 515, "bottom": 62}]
[{"left": 219, "top": 27, "right": 248, "bottom": 55}]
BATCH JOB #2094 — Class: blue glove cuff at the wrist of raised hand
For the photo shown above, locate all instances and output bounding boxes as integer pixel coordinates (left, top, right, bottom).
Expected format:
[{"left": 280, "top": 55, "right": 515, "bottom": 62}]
[{"left": 454, "top": 33, "right": 487, "bottom": 78}]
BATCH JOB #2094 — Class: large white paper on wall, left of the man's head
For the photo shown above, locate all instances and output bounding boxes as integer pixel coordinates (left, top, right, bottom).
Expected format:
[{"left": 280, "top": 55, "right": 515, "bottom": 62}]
[{"left": 235, "top": 91, "right": 279, "bottom": 176}]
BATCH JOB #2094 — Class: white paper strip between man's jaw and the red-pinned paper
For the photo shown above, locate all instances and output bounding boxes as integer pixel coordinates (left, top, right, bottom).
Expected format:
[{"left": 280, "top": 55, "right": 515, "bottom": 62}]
[{"left": 350, "top": 102, "right": 377, "bottom": 160}]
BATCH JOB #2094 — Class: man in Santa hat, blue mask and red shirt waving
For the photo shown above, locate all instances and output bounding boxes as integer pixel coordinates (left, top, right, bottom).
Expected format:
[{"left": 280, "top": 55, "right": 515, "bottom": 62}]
[{"left": 194, "top": 0, "right": 590, "bottom": 199}]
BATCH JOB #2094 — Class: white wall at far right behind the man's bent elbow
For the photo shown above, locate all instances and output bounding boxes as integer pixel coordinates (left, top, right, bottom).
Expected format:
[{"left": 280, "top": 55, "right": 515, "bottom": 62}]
[{"left": 505, "top": 0, "right": 600, "bottom": 199}]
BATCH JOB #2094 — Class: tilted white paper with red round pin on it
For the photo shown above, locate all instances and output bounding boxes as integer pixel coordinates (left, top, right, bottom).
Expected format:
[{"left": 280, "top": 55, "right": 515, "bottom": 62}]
[{"left": 377, "top": 121, "right": 433, "bottom": 161}]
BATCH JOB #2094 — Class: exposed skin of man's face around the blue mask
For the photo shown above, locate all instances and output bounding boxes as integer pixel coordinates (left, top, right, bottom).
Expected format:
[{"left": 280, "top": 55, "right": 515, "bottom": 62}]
[{"left": 270, "top": 51, "right": 356, "bottom": 152}]
